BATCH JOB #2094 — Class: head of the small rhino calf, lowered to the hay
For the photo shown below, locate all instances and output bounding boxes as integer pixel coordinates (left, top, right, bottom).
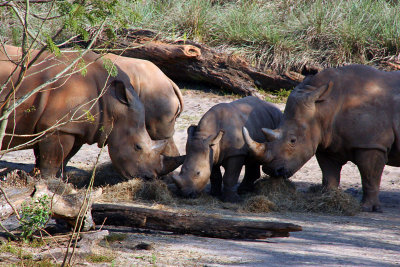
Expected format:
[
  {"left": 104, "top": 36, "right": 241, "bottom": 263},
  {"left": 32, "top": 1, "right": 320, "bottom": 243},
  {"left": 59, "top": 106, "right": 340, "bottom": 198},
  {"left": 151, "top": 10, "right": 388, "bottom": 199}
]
[{"left": 173, "top": 125, "right": 224, "bottom": 198}]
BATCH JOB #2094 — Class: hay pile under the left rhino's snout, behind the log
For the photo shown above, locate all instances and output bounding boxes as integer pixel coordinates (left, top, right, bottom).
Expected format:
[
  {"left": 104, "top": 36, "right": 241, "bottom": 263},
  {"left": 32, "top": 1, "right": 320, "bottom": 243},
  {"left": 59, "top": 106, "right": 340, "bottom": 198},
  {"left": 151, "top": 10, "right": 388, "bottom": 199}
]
[{"left": 101, "top": 178, "right": 175, "bottom": 204}]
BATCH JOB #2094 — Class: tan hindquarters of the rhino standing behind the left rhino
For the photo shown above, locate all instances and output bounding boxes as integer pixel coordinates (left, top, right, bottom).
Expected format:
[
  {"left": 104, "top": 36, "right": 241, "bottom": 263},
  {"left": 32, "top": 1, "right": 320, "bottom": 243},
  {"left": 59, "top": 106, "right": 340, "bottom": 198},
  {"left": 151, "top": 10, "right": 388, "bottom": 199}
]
[{"left": 104, "top": 54, "right": 183, "bottom": 156}]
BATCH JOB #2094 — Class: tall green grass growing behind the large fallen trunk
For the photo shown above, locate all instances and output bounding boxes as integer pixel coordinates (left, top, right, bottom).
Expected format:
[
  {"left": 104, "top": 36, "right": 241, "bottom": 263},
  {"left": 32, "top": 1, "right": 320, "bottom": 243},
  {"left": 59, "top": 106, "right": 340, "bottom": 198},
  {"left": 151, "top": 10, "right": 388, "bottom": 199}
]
[{"left": 125, "top": 0, "right": 400, "bottom": 70}]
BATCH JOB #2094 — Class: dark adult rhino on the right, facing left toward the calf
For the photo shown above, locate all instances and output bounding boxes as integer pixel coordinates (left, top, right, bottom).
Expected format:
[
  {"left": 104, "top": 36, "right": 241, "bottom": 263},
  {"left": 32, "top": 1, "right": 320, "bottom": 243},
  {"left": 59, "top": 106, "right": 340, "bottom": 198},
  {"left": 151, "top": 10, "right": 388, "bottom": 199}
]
[{"left": 244, "top": 65, "right": 400, "bottom": 211}]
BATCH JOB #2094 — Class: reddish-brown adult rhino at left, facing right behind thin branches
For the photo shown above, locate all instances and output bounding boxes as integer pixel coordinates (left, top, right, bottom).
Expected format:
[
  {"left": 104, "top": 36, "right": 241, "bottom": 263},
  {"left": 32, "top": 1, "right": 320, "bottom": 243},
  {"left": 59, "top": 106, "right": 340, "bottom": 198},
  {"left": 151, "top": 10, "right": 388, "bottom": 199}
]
[{"left": 0, "top": 45, "right": 178, "bottom": 178}]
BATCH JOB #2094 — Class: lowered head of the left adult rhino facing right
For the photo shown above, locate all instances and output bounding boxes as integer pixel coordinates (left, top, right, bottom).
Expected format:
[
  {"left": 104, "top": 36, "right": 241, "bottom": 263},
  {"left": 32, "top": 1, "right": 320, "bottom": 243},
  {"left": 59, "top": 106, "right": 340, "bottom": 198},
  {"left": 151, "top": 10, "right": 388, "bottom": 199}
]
[{"left": 103, "top": 81, "right": 182, "bottom": 179}]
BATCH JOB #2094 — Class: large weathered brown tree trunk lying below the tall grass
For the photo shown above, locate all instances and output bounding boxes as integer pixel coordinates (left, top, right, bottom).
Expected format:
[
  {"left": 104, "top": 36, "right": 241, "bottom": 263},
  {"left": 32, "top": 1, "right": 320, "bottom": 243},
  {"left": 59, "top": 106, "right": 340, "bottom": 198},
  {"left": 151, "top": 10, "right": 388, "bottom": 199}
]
[{"left": 92, "top": 30, "right": 304, "bottom": 97}]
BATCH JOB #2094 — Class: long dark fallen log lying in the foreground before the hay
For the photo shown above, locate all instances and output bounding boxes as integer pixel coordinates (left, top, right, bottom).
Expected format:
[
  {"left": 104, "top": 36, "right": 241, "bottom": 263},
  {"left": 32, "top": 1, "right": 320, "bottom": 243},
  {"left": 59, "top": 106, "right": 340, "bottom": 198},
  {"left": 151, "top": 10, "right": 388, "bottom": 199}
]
[{"left": 92, "top": 203, "right": 302, "bottom": 239}]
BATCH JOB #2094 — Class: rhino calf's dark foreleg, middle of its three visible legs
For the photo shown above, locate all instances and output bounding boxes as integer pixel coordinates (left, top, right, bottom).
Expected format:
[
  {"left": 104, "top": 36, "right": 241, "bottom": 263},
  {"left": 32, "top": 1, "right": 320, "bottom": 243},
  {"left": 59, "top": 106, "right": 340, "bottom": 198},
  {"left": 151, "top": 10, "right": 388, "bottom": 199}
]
[{"left": 222, "top": 157, "right": 244, "bottom": 202}]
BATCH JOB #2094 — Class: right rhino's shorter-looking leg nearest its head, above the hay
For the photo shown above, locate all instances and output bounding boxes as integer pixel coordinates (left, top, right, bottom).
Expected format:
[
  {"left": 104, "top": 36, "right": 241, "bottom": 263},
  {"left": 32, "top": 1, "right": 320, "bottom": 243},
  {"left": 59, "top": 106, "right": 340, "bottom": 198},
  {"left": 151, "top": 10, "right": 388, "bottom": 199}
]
[{"left": 316, "top": 151, "right": 344, "bottom": 189}]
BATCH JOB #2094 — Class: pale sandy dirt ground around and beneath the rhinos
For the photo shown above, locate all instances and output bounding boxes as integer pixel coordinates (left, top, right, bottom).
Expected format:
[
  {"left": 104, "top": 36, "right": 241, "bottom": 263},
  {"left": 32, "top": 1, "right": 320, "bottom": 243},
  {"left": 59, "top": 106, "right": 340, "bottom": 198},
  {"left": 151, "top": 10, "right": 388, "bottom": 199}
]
[{"left": 0, "top": 89, "right": 400, "bottom": 266}]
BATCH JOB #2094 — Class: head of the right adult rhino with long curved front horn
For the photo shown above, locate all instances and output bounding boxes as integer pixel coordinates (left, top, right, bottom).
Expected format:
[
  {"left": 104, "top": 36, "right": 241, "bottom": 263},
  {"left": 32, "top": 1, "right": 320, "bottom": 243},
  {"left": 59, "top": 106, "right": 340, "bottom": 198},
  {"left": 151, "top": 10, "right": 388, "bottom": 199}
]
[{"left": 243, "top": 81, "right": 333, "bottom": 178}]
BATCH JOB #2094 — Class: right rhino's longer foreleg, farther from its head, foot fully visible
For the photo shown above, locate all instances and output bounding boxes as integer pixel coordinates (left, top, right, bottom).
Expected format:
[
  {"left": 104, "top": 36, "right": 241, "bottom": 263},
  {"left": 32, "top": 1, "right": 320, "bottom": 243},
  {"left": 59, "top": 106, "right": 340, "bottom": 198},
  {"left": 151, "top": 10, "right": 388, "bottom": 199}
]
[{"left": 354, "top": 149, "right": 387, "bottom": 212}]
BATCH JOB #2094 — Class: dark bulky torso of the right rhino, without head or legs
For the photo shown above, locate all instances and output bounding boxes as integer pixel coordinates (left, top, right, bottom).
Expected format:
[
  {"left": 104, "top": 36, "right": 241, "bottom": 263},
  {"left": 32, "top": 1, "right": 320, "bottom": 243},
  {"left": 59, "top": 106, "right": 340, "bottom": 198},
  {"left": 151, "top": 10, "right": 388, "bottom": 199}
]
[{"left": 302, "top": 65, "right": 400, "bottom": 160}]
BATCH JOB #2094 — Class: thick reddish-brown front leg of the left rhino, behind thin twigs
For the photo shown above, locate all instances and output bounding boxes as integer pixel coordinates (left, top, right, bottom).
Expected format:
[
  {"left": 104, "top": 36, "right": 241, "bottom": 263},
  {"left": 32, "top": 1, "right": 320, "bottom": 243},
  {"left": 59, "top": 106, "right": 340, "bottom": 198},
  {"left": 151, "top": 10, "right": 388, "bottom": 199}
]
[{"left": 38, "top": 133, "right": 75, "bottom": 178}]
